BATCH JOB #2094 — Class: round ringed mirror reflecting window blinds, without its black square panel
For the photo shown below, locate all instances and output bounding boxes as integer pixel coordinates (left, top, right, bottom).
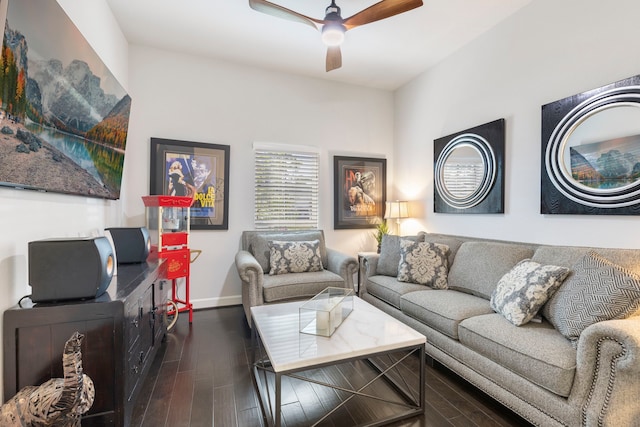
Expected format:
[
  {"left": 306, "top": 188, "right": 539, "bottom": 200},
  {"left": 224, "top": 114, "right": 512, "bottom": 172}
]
[{"left": 434, "top": 134, "right": 496, "bottom": 209}]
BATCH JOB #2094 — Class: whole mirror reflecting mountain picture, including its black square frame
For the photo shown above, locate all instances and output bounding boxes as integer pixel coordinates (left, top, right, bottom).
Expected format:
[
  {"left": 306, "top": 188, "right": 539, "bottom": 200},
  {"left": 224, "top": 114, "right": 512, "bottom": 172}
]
[{"left": 540, "top": 76, "right": 640, "bottom": 215}]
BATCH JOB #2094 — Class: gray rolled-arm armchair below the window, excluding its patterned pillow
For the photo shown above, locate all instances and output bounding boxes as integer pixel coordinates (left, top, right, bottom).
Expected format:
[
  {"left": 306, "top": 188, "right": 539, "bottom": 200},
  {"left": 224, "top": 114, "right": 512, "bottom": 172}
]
[{"left": 235, "top": 230, "right": 358, "bottom": 326}]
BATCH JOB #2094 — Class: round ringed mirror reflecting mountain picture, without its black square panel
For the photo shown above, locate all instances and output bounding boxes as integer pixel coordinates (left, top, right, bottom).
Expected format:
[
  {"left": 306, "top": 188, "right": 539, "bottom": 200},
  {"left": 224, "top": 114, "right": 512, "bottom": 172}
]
[{"left": 545, "top": 87, "right": 640, "bottom": 208}]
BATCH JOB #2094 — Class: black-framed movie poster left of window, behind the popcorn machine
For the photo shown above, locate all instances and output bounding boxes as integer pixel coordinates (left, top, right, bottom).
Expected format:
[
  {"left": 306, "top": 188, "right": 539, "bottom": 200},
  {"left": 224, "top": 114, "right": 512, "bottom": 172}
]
[{"left": 149, "top": 138, "right": 230, "bottom": 230}]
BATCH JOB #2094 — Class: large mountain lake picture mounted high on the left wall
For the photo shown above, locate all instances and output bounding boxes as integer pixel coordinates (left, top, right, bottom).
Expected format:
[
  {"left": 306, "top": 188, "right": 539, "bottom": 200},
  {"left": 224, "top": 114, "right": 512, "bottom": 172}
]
[{"left": 0, "top": 0, "right": 131, "bottom": 199}]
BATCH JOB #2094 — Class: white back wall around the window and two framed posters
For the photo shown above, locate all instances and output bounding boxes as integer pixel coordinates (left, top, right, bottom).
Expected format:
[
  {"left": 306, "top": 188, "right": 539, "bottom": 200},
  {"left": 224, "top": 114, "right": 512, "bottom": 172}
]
[{"left": 123, "top": 46, "right": 393, "bottom": 308}]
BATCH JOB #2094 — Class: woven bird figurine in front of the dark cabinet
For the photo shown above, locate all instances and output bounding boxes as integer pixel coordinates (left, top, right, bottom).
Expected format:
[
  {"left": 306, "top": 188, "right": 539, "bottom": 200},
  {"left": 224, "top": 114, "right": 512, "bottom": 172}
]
[{"left": 0, "top": 332, "right": 95, "bottom": 427}]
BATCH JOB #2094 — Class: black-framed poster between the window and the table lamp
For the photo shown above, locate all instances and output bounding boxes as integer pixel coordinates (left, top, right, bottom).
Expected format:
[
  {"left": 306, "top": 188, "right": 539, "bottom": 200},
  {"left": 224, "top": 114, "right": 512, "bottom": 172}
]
[{"left": 333, "top": 156, "right": 387, "bottom": 229}]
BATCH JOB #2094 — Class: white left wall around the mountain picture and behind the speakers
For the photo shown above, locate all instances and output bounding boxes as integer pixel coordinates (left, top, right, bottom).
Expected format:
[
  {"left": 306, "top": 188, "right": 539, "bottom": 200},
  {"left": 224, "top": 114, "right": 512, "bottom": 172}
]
[{"left": 0, "top": 0, "right": 128, "bottom": 402}]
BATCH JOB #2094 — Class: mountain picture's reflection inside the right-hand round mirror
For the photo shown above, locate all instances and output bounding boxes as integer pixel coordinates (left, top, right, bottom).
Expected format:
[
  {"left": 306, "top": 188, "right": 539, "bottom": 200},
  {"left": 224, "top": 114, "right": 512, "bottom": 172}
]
[{"left": 569, "top": 135, "right": 640, "bottom": 190}]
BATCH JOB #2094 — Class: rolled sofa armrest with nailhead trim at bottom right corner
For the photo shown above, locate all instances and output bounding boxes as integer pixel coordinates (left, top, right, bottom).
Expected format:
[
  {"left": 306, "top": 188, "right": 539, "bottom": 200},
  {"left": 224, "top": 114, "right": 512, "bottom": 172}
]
[{"left": 569, "top": 316, "right": 640, "bottom": 426}]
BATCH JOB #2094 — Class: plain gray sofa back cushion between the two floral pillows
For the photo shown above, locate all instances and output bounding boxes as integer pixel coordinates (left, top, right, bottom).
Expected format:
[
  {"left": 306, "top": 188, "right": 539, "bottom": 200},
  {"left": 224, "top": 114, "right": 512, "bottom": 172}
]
[{"left": 448, "top": 242, "right": 533, "bottom": 299}]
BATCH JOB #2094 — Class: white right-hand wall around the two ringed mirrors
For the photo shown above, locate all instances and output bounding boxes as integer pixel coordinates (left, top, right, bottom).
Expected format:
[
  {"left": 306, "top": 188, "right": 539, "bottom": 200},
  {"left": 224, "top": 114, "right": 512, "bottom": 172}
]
[{"left": 394, "top": 0, "right": 640, "bottom": 248}]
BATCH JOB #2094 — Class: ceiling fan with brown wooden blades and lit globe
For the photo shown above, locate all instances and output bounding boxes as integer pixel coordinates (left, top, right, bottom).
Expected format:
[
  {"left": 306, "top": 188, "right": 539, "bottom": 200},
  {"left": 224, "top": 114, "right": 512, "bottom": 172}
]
[{"left": 249, "top": 0, "right": 422, "bottom": 72}]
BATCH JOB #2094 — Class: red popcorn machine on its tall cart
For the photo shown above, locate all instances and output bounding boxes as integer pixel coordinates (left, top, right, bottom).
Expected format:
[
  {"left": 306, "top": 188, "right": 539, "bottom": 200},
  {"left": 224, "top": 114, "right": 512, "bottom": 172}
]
[{"left": 142, "top": 195, "right": 201, "bottom": 326}]
